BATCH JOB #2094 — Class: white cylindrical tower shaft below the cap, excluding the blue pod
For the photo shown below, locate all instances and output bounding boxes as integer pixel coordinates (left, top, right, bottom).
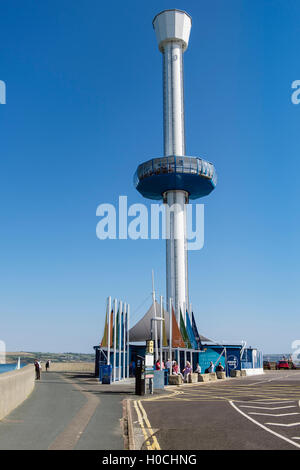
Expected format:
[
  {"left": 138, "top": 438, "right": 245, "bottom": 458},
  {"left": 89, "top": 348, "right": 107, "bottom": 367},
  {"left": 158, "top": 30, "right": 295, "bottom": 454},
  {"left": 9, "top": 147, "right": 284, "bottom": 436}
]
[{"left": 162, "top": 35, "right": 189, "bottom": 312}]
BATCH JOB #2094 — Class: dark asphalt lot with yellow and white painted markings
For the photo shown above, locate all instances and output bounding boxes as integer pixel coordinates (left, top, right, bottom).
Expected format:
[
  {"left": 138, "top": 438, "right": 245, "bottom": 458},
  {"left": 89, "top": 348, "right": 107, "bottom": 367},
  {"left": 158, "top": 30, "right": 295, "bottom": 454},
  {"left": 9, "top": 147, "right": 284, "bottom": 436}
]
[{"left": 131, "top": 371, "right": 300, "bottom": 450}]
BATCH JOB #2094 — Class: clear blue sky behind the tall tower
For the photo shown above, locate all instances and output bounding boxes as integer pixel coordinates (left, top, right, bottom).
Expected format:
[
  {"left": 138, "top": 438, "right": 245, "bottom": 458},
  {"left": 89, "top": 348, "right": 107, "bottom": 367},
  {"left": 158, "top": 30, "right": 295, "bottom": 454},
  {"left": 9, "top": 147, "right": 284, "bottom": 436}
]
[{"left": 0, "top": 0, "right": 300, "bottom": 353}]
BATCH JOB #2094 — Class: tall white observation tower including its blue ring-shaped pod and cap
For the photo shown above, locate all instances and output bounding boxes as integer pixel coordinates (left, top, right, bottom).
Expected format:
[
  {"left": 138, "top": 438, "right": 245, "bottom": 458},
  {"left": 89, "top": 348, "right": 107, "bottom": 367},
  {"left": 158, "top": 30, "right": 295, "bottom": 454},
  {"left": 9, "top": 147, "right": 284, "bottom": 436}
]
[{"left": 135, "top": 10, "right": 217, "bottom": 320}]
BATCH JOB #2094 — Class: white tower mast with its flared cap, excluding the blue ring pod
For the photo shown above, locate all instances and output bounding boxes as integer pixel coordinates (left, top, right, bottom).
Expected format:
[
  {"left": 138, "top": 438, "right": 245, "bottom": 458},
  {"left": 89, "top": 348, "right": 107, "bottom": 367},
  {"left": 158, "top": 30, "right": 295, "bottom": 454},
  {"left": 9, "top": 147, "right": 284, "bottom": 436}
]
[{"left": 153, "top": 10, "right": 192, "bottom": 316}]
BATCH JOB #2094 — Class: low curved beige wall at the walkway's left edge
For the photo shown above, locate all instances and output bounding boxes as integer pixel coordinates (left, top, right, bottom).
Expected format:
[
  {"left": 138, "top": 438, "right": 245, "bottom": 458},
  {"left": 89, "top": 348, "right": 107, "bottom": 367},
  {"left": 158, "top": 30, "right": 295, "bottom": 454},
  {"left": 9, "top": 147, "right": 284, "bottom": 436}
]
[{"left": 0, "top": 365, "right": 35, "bottom": 419}]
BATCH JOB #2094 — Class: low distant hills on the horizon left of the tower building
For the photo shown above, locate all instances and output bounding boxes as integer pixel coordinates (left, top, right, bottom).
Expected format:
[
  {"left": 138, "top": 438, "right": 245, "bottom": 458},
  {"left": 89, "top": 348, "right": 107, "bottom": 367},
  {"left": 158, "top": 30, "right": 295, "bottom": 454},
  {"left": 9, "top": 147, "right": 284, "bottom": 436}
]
[{"left": 6, "top": 351, "right": 95, "bottom": 363}]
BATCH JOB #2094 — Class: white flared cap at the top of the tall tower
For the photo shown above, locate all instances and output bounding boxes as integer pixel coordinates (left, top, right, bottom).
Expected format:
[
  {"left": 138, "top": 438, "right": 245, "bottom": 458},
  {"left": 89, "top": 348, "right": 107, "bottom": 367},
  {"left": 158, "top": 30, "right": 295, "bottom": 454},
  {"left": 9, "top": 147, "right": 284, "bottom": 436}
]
[{"left": 152, "top": 10, "right": 192, "bottom": 52}]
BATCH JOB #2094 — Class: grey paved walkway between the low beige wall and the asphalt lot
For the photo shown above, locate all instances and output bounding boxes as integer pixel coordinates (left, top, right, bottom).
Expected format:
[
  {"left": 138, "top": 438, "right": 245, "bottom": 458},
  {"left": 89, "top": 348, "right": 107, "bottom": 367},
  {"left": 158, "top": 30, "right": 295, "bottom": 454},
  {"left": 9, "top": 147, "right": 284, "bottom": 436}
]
[{"left": 0, "top": 372, "right": 134, "bottom": 450}]
